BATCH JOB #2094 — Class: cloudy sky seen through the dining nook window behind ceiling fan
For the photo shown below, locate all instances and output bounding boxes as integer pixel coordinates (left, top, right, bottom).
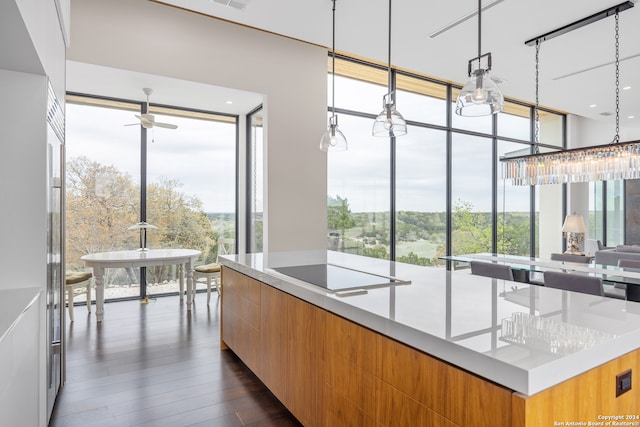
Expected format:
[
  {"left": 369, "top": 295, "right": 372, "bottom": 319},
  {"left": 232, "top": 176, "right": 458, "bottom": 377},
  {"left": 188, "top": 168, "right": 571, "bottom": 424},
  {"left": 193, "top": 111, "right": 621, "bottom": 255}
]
[{"left": 66, "top": 103, "right": 236, "bottom": 212}]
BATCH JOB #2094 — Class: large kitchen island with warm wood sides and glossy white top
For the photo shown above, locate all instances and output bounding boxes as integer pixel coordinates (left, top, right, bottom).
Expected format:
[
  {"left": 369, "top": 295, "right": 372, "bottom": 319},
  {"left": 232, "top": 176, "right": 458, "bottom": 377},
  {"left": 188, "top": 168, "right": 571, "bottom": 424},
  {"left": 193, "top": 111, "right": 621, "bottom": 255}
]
[{"left": 220, "top": 252, "right": 640, "bottom": 427}]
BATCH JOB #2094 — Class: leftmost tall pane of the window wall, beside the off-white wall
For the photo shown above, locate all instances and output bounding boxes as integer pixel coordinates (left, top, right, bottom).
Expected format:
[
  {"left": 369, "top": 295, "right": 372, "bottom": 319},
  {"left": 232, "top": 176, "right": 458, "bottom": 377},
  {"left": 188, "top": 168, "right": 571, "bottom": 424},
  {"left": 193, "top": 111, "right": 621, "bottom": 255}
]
[{"left": 327, "top": 61, "right": 391, "bottom": 259}]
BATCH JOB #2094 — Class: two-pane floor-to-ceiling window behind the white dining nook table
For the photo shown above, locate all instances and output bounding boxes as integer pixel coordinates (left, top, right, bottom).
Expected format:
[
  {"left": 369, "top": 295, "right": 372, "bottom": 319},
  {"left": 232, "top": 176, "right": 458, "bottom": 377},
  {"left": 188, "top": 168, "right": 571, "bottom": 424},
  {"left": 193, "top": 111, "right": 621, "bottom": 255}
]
[{"left": 66, "top": 95, "right": 237, "bottom": 298}]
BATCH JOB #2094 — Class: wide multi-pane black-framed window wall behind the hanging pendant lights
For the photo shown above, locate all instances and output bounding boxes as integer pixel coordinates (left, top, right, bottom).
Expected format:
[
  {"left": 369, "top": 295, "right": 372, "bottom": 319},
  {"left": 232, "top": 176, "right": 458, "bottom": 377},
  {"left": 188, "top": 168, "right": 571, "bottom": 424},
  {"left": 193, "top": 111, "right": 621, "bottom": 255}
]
[{"left": 328, "top": 57, "right": 565, "bottom": 265}]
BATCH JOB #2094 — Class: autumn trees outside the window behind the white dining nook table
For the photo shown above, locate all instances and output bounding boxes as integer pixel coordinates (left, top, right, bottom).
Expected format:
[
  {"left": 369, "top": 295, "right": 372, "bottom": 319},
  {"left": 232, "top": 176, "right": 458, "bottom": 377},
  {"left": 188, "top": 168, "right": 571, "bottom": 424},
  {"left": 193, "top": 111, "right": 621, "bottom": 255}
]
[{"left": 66, "top": 157, "right": 218, "bottom": 283}]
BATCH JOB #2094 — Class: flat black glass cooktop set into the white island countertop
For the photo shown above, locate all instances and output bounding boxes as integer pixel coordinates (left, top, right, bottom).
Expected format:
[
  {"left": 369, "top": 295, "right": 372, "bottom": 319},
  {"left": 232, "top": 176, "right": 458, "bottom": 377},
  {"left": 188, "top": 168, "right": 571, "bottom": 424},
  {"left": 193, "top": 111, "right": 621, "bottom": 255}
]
[{"left": 274, "top": 264, "right": 410, "bottom": 291}]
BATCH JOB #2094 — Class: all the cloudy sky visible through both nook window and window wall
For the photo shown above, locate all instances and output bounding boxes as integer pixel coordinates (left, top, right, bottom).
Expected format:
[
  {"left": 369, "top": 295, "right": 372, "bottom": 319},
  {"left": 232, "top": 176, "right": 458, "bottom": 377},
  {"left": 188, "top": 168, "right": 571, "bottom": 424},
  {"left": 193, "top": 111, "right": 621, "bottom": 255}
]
[{"left": 66, "top": 75, "right": 540, "bottom": 217}]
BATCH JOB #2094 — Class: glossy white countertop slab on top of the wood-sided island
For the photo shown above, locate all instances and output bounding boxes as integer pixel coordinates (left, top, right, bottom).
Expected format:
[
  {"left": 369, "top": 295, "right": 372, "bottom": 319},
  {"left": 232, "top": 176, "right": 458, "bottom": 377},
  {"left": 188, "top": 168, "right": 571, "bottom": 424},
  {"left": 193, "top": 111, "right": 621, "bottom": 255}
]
[{"left": 220, "top": 251, "right": 640, "bottom": 395}]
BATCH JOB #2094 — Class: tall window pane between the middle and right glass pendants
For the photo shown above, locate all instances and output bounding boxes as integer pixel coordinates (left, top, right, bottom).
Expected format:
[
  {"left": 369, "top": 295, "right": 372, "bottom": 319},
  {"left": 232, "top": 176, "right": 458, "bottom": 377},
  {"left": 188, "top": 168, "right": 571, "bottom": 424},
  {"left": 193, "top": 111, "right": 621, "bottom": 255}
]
[{"left": 395, "top": 75, "right": 447, "bottom": 265}]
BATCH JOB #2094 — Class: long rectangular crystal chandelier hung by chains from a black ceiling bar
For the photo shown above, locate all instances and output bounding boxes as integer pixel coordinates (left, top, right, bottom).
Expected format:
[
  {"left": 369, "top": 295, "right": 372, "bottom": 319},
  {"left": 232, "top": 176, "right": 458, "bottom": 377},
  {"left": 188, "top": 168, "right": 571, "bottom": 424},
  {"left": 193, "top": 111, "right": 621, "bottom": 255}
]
[{"left": 500, "top": 1, "right": 640, "bottom": 185}]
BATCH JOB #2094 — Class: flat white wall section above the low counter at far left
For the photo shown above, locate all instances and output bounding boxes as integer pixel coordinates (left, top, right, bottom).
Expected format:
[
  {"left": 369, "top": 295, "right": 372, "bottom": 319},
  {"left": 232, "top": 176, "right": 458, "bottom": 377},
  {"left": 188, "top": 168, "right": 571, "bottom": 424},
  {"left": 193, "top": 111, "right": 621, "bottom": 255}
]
[{"left": 0, "top": 70, "right": 47, "bottom": 289}]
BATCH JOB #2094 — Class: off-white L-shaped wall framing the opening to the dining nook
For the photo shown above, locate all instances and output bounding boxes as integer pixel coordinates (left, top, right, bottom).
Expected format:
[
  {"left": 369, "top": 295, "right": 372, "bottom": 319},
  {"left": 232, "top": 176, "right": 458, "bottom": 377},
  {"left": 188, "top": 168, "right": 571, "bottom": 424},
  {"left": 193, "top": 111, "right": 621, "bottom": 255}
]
[{"left": 67, "top": 0, "right": 327, "bottom": 251}]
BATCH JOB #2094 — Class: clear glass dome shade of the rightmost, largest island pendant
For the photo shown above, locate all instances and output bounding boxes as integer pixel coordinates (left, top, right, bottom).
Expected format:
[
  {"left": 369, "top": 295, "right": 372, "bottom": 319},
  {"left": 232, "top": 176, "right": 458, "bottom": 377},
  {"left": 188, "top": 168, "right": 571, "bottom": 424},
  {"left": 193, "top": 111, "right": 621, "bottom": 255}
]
[{"left": 456, "top": 68, "right": 504, "bottom": 117}]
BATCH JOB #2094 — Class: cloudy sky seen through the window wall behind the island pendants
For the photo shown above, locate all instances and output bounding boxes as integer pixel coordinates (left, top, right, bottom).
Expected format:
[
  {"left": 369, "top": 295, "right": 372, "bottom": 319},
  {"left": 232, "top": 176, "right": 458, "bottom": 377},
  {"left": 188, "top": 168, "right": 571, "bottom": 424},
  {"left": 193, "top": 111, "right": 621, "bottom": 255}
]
[{"left": 328, "top": 76, "right": 529, "bottom": 212}]
